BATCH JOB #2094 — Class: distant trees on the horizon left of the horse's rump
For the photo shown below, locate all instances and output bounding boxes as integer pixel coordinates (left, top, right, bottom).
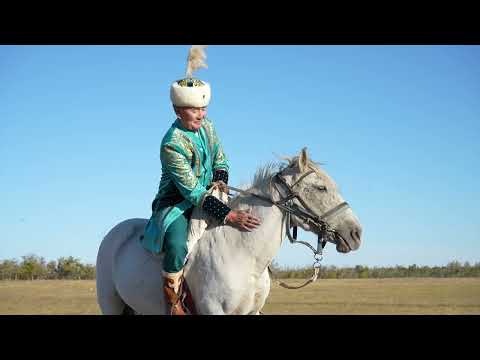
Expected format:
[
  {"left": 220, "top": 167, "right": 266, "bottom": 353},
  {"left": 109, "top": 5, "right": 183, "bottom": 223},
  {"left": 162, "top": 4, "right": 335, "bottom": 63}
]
[{"left": 0, "top": 255, "right": 95, "bottom": 280}]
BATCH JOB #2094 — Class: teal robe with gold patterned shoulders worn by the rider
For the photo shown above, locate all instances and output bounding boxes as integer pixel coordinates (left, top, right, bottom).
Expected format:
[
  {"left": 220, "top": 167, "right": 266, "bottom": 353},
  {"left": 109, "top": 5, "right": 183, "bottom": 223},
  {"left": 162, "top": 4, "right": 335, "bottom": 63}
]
[{"left": 141, "top": 118, "right": 229, "bottom": 254}]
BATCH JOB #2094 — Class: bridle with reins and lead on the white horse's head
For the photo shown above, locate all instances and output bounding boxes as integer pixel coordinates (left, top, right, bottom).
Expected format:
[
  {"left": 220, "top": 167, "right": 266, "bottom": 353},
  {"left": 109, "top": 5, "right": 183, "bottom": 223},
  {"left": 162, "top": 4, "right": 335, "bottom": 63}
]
[{"left": 228, "top": 170, "right": 350, "bottom": 289}]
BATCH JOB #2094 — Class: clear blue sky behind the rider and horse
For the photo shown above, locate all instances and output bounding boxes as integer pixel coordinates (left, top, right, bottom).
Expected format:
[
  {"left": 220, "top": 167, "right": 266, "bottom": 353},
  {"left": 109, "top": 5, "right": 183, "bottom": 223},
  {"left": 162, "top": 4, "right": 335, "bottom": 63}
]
[{"left": 0, "top": 45, "right": 480, "bottom": 266}]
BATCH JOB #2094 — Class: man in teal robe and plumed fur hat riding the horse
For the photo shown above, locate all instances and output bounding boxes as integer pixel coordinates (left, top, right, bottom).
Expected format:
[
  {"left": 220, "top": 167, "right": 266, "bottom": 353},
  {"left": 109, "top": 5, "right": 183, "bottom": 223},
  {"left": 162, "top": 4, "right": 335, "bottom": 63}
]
[{"left": 141, "top": 46, "right": 260, "bottom": 315}]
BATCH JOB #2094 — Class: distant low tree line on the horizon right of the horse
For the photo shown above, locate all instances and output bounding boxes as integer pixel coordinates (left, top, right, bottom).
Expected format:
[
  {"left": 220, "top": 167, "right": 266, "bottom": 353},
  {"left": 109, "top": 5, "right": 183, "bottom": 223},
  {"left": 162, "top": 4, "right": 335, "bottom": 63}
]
[{"left": 272, "top": 261, "right": 480, "bottom": 279}]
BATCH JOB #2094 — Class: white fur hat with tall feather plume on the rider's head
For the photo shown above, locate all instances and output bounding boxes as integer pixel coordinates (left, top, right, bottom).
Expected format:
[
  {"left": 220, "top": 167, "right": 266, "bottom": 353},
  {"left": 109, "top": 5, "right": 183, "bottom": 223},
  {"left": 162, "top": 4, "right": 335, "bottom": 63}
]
[{"left": 170, "top": 45, "right": 211, "bottom": 107}]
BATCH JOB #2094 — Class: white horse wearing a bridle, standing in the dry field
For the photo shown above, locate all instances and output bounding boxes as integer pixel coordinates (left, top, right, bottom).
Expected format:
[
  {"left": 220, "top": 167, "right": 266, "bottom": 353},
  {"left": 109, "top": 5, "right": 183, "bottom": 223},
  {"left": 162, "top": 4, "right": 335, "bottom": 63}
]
[{"left": 96, "top": 149, "right": 362, "bottom": 315}]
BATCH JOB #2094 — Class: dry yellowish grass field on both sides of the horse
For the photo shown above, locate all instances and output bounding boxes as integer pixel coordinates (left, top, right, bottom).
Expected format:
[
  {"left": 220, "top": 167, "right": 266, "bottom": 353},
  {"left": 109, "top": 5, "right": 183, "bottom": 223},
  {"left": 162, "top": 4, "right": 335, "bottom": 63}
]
[{"left": 0, "top": 278, "right": 480, "bottom": 315}]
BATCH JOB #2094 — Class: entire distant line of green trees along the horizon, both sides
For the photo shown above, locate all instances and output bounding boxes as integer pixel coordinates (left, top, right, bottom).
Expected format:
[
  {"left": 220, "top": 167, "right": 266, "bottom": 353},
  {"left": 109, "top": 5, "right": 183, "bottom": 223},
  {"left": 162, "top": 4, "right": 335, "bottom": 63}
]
[{"left": 0, "top": 255, "right": 480, "bottom": 280}]
